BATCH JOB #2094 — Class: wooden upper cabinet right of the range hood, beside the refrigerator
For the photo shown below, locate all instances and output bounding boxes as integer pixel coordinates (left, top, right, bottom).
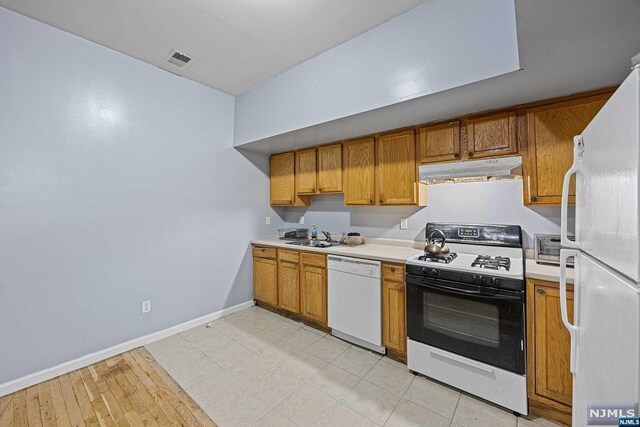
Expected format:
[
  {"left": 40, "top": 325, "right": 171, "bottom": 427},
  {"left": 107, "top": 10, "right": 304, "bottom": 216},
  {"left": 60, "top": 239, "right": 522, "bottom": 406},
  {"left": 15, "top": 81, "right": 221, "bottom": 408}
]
[{"left": 524, "top": 94, "right": 609, "bottom": 205}]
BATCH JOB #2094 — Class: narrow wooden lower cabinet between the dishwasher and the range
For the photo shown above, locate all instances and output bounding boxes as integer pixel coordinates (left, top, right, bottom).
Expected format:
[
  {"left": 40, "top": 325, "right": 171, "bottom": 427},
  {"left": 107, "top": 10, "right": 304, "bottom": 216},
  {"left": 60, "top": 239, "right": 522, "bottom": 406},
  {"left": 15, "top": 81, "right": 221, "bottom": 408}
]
[{"left": 382, "top": 263, "right": 407, "bottom": 358}]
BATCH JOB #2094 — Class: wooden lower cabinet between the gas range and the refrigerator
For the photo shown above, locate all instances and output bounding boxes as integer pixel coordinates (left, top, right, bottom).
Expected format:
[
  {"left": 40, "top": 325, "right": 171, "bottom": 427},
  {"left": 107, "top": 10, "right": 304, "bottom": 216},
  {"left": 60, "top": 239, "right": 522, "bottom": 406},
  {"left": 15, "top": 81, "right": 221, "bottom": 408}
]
[{"left": 527, "top": 279, "right": 573, "bottom": 425}]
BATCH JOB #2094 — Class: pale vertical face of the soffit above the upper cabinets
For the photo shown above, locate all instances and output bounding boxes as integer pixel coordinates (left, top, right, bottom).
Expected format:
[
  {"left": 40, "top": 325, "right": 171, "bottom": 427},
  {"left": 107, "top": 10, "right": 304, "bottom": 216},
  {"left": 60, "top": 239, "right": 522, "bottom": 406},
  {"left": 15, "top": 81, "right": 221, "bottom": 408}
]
[{"left": 234, "top": 0, "right": 519, "bottom": 145}]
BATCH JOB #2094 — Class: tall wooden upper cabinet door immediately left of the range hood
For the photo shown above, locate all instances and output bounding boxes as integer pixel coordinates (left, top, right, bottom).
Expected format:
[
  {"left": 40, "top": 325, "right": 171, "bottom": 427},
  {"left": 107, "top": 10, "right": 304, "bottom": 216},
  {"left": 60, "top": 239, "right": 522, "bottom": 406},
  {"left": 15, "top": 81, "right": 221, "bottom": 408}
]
[{"left": 378, "top": 130, "right": 416, "bottom": 205}]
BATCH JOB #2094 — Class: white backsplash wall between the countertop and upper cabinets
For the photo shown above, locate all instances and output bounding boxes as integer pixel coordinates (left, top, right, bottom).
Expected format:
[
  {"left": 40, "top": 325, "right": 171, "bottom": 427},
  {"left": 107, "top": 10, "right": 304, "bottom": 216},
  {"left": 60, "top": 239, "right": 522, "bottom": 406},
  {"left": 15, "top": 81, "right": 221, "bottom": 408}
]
[{"left": 279, "top": 179, "right": 573, "bottom": 247}]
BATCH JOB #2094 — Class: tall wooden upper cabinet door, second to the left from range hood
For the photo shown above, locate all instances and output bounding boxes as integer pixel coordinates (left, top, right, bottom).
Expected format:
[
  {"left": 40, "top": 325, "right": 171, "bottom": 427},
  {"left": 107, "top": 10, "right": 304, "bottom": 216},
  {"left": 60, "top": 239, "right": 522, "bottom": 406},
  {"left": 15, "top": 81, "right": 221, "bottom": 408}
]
[{"left": 343, "top": 138, "right": 376, "bottom": 205}]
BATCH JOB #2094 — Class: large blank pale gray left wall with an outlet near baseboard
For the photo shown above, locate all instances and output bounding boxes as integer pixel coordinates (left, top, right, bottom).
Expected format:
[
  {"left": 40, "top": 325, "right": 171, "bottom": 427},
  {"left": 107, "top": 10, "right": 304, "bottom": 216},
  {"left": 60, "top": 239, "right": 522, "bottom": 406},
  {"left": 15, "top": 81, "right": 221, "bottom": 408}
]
[{"left": 0, "top": 8, "right": 278, "bottom": 384}]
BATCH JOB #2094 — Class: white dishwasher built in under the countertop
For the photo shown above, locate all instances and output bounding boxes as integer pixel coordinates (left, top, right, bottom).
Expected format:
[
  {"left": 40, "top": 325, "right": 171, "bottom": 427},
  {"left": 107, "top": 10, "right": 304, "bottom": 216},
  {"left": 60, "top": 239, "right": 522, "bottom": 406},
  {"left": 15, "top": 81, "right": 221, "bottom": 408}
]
[{"left": 327, "top": 255, "right": 385, "bottom": 353}]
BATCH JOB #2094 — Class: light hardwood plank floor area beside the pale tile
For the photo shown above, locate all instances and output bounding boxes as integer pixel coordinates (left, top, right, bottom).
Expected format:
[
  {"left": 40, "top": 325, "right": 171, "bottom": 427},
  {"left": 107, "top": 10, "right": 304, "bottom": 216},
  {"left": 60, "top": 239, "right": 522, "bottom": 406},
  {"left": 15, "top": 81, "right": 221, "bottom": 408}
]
[{"left": 0, "top": 348, "right": 215, "bottom": 427}]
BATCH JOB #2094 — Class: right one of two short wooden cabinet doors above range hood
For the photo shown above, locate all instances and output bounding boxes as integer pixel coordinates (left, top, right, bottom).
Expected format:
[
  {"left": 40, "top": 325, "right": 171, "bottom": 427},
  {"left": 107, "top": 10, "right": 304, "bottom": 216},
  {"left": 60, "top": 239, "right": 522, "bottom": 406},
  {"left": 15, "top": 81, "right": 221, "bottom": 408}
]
[{"left": 467, "top": 111, "right": 518, "bottom": 158}]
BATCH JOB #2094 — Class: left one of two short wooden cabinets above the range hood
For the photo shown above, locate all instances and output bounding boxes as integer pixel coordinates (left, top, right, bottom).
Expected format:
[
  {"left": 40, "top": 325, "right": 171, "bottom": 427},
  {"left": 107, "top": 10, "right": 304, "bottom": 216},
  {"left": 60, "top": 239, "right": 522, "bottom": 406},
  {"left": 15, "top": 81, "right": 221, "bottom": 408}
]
[{"left": 418, "top": 121, "right": 462, "bottom": 164}]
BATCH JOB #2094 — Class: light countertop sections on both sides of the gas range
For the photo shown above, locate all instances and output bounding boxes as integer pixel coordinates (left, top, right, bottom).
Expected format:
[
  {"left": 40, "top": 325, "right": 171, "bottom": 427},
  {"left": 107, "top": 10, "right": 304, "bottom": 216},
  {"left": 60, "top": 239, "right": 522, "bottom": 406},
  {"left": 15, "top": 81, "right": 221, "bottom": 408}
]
[{"left": 251, "top": 237, "right": 573, "bottom": 283}]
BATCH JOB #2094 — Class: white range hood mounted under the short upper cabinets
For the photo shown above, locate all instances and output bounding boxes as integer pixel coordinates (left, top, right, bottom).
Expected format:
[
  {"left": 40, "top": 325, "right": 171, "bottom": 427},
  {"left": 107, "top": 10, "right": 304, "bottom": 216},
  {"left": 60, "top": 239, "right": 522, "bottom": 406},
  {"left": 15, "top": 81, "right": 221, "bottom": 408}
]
[{"left": 419, "top": 156, "right": 522, "bottom": 183}]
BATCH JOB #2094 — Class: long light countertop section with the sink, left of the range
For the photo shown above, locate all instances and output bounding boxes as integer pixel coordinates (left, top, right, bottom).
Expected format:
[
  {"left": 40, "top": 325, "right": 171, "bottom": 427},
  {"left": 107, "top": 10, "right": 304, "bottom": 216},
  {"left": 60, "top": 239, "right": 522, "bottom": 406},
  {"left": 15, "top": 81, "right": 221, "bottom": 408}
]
[{"left": 251, "top": 238, "right": 424, "bottom": 264}]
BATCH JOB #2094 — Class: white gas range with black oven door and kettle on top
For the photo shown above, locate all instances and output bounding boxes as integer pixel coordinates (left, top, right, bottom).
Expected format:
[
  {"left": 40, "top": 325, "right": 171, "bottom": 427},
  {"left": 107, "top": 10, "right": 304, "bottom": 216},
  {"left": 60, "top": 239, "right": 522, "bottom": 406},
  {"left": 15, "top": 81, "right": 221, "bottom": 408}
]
[{"left": 406, "top": 223, "right": 527, "bottom": 414}]
